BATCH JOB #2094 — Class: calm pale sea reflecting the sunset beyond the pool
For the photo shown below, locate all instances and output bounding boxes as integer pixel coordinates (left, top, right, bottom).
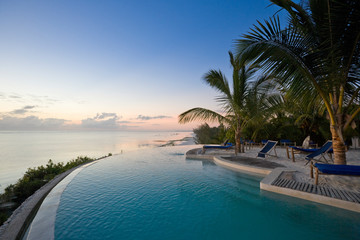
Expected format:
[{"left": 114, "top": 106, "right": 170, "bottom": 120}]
[{"left": 0, "top": 131, "right": 192, "bottom": 192}]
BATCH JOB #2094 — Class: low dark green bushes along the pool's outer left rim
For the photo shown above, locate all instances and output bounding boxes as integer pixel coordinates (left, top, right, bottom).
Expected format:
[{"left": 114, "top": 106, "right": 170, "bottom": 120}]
[{"left": 0, "top": 157, "right": 95, "bottom": 225}]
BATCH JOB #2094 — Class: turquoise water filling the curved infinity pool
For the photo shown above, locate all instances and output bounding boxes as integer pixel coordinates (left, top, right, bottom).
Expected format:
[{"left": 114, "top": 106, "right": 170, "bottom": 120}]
[{"left": 55, "top": 147, "right": 360, "bottom": 240}]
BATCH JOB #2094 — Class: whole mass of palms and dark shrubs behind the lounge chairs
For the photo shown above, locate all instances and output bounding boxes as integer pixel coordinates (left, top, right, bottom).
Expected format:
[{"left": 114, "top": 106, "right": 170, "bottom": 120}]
[{"left": 179, "top": 0, "right": 360, "bottom": 164}]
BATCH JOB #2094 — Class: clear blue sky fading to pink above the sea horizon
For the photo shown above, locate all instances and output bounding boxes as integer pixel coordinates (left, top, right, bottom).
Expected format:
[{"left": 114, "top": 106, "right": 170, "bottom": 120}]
[{"left": 0, "top": 0, "right": 279, "bottom": 131}]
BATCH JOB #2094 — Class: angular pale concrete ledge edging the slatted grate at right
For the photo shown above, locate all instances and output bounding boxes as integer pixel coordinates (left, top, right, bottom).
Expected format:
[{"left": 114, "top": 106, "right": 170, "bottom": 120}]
[{"left": 260, "top": 169, "right": 360, "bottom": 212}]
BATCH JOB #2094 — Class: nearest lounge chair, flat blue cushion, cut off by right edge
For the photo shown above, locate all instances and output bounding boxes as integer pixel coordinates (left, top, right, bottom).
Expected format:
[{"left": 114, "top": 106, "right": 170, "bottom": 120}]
[{"left": 310, "top": 163, "right": 360, "bottom": 185}]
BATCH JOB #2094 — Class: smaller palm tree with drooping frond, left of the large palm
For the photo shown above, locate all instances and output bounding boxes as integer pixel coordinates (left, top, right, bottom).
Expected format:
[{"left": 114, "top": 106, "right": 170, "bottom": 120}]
[{"left": 179, "top": 52, "right": 269, "bottom": 154}]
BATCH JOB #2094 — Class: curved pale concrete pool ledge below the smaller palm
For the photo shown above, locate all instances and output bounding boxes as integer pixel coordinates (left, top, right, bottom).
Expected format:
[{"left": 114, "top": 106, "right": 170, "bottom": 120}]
[{"left": 213, "top": 156, "right": 272, "bottom": 176}]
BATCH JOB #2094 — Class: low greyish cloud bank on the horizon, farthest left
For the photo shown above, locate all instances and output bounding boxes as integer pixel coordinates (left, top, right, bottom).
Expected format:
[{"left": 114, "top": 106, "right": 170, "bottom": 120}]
[{"left": 0, "top": 116, "right": 67, "bottom": 131}]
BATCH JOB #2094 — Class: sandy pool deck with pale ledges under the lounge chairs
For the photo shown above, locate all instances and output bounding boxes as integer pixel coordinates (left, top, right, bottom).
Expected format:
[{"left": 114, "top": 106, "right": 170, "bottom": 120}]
[{"left": 186, "top": 147, "right": 360, "bottom": 213}]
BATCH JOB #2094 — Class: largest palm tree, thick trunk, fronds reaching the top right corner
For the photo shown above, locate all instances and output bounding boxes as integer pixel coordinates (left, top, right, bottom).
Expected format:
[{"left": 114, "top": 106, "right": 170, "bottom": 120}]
[{"left": 236, "top": 0, "right": 360, "bottom": 164}]
